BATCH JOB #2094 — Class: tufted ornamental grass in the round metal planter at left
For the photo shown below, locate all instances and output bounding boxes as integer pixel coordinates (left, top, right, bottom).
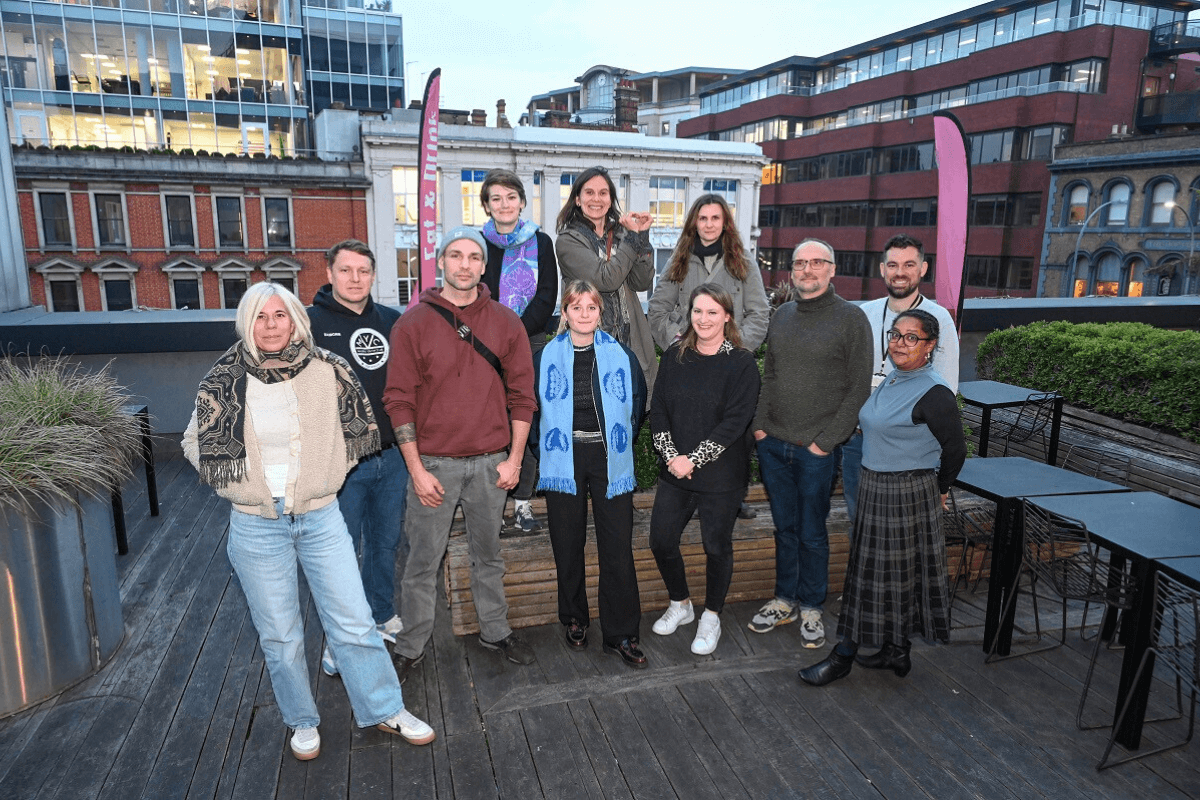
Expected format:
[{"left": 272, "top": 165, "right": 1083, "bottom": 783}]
[{"left": 0, "top": 356, "right": 142, "bottom": 507}]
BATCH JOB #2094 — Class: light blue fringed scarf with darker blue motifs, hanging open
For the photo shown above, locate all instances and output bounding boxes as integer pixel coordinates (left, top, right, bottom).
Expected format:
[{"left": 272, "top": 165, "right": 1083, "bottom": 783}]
[{"left": 538, "top": 330, "right": 636, "bottom": 500}]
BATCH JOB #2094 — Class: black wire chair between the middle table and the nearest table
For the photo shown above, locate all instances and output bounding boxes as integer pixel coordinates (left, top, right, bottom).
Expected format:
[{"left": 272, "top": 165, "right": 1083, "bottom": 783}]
[{"left": 985, "top": 500, "right": 1136, "bottom": 730}]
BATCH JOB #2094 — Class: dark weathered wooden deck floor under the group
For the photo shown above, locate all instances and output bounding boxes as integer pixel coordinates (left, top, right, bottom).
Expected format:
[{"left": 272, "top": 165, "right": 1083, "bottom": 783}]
[{"left": 0, "top": 453, "right": 1200, "bottom": 800}]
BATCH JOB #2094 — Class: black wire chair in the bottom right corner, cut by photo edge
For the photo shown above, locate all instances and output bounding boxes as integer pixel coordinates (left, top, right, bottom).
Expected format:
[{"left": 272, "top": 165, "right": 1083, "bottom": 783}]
[{"left": 1096, "top": 572, "right": 1200, "bottom": 770}]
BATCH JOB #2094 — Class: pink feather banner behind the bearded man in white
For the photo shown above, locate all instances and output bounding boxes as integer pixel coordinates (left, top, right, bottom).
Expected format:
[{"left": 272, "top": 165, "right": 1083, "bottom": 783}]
[{"left": 934, "top": 112, "right": 971, "bottom": 330}]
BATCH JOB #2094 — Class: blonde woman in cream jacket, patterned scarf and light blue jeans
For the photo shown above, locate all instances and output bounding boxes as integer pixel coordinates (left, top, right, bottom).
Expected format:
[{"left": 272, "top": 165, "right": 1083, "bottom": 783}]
[{"left": 184, "top": 283, "right": 434, "bottom": 760}]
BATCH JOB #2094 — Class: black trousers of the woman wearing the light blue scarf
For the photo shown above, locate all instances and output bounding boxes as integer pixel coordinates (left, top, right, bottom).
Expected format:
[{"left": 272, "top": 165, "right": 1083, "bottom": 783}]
[{"left": 546, "top": 441, "right": 642, "bottom": 645}]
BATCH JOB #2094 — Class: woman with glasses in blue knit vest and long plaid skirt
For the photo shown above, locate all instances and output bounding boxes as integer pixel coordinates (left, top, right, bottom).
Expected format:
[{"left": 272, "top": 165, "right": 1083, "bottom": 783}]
[{"left": 799, "top": 308, "right": 967, "bottom": 686}]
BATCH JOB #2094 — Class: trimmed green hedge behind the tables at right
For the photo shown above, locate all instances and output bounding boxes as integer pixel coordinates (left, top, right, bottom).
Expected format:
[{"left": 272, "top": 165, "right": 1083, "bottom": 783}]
[{"left": 976, "top": 321, "right": 1200, "bottom": 441}]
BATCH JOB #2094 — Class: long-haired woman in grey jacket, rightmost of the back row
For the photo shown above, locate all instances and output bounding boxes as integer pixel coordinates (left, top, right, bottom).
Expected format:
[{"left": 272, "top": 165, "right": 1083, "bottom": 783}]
[{"left": 649, "top": 194, "right": 770, "bottom": 353}]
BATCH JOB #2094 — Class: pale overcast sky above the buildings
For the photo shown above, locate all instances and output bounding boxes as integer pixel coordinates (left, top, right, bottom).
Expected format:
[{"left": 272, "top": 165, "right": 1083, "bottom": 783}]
[{"left": 394, "top": 0, "right": 980, "bottom": 125}]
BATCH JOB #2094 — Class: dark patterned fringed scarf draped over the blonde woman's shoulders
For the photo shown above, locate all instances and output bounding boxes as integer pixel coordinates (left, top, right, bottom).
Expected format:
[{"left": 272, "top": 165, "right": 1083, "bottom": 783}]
[{"left": 196, "top": 341, "right": 379, "bottom": 489}]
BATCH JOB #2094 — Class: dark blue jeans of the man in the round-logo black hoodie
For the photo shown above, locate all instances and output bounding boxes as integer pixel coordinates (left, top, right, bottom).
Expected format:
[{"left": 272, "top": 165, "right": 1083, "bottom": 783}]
[{"left": 337, "top": 447, "right": 408, "bottom": 622}]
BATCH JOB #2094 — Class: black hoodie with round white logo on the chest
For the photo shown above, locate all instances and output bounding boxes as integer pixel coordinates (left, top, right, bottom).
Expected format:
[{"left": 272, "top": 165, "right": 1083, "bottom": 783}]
[{"left": 308, "top": 283, "right": 400, "bottom": 447}]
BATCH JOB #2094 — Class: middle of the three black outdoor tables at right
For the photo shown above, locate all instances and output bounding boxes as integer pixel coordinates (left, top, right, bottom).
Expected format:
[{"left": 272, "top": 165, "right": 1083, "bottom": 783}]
[{"left": 954, "top": 456, "right": 1129, "bottom": 656}]
